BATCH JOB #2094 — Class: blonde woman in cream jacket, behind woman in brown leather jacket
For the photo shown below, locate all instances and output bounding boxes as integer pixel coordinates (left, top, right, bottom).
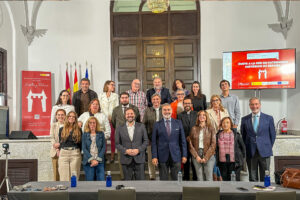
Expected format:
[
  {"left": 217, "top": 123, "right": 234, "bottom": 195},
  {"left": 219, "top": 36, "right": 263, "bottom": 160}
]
[{"left": 206, "top": 94, "right": 229, "bottom": 133}]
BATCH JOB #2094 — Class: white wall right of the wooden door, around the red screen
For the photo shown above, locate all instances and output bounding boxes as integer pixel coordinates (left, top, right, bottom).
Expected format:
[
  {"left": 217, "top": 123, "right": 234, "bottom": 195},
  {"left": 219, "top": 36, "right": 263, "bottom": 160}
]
[{"left": 200, "top": 1, "right": 286, "bottom": 126}]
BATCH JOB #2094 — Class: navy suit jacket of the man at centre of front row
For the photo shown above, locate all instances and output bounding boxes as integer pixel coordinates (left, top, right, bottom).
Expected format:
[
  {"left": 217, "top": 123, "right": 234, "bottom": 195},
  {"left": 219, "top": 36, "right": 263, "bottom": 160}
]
[{"left": 151, "top": 119, "right": 187, "bottom": 163}]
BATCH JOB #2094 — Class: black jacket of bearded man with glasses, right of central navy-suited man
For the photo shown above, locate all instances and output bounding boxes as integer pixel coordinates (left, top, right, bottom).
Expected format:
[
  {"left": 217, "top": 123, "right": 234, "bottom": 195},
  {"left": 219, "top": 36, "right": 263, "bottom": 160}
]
[{"left": 177, "top": 110, "right": 197, "bottom": 138}]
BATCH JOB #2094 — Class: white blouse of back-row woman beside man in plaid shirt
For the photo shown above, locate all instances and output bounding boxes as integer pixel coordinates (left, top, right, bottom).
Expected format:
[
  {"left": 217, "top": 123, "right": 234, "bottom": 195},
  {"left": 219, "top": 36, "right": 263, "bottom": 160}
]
[{"left": 99, "top": 92, "right": 119, "bottom": 118}]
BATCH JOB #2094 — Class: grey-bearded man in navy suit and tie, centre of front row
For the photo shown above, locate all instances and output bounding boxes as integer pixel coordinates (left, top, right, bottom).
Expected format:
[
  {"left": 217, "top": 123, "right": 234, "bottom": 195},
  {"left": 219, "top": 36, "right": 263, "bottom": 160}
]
[{"left": 152, "top": 104, "right": 187, "bottom": 180}]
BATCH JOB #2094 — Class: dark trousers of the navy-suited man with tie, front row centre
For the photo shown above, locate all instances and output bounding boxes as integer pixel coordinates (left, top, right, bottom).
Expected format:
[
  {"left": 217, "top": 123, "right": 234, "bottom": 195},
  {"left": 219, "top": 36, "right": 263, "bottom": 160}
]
[{"left": 158, "top": 153, "right": 181, "bottom": 181}]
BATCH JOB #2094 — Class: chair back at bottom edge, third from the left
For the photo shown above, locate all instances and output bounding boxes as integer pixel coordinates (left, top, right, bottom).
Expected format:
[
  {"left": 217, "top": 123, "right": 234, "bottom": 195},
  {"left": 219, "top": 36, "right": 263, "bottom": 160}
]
[{"left": 182, "top": 187, "right": 220, "bottom": 200}]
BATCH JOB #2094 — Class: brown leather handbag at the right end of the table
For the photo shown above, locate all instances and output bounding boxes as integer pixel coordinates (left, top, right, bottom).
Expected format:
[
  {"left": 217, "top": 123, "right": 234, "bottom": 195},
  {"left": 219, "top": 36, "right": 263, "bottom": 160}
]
[{"left": 281, "top": 168, "right": 300, "bottom": 189}]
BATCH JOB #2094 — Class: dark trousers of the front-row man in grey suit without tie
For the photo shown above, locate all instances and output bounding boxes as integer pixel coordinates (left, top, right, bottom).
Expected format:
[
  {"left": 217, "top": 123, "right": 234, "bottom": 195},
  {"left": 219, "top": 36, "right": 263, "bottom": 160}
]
[{"left": 122, "top": 159, "right": 145, "bottom": 180}]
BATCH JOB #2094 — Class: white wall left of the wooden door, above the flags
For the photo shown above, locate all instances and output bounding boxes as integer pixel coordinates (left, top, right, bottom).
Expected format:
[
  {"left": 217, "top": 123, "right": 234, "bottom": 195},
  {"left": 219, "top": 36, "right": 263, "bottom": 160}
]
[{"left": 28, "top": 0, "right": 111, "bottom": 103}]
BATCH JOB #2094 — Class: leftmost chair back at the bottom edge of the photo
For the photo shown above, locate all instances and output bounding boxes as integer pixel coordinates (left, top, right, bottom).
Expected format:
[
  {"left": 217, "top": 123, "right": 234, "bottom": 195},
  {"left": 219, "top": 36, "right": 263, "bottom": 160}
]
[{"left": 29, "top": 191, "right": 69, "bottom": 200}]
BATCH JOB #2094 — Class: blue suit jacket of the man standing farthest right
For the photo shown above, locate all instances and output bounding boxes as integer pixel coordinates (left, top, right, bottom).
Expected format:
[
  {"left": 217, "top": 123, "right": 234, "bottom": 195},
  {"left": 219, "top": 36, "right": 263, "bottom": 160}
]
[{"left": 241, "top": 112, "right": 276, "bottom": 158}]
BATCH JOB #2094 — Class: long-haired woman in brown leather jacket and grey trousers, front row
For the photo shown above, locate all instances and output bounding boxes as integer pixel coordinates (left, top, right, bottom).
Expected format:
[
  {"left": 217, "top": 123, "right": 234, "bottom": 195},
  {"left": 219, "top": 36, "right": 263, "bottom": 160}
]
[{"left": 187, "top": 110, "right": 216, "bottom": 181}]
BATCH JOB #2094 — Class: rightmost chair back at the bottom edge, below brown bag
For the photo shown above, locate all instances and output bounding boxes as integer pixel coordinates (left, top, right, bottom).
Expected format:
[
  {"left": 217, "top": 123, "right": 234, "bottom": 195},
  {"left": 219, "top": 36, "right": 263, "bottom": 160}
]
[{"left": 256, "top": 191, "right": 296, "bottom": 200}]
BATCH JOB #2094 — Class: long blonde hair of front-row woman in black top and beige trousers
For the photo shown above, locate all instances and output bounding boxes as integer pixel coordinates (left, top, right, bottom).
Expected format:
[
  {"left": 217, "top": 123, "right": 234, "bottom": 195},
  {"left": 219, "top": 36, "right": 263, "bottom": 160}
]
[{"left": 61, "top": 111, "right": 81, "bottom": 143}]
